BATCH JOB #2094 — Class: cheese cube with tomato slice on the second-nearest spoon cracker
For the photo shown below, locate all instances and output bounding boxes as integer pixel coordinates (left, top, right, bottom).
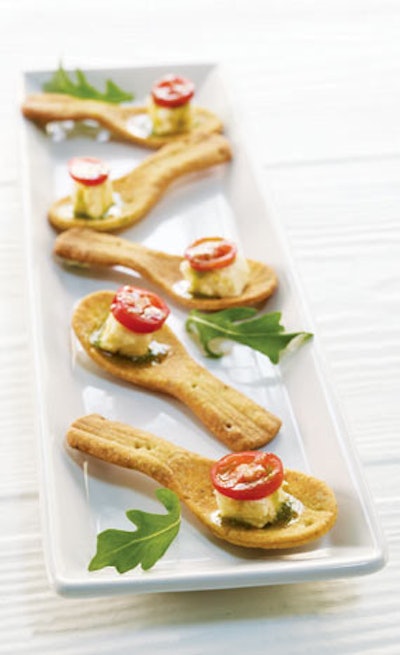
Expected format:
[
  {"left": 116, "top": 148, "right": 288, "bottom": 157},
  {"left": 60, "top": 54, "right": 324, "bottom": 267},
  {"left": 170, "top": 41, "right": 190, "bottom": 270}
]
[{"left": 93, "top": 285, "right": 169, "bottom": 361}]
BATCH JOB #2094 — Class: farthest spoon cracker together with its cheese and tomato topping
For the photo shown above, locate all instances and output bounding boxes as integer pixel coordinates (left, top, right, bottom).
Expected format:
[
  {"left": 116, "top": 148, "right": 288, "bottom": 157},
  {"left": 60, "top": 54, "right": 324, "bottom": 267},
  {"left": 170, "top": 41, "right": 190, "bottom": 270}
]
[{"left": 22, "top": 71, "right": 223, "bottom": 149}]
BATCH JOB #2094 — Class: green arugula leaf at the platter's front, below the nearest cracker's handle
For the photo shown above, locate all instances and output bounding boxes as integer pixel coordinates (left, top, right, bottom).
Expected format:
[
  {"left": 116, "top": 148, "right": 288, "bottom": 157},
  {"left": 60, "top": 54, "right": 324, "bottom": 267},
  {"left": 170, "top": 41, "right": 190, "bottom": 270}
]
[{"left": 88, "top": 489, "right": 181, "bottom": 573}]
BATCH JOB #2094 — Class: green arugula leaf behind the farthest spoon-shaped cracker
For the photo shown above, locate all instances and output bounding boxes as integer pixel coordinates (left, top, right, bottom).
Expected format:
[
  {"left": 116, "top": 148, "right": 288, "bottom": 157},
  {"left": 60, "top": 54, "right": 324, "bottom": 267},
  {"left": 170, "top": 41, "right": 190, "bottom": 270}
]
[{"left": 42, "top": 64, "right": 134, "bottom": 104}]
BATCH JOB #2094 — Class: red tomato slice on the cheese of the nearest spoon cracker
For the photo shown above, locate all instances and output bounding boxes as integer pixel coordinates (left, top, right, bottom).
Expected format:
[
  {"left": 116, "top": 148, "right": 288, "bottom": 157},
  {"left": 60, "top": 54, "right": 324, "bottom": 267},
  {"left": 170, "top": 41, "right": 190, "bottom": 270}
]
[{"left": 211, "top": 450, "right": 283, "bottom": 500}]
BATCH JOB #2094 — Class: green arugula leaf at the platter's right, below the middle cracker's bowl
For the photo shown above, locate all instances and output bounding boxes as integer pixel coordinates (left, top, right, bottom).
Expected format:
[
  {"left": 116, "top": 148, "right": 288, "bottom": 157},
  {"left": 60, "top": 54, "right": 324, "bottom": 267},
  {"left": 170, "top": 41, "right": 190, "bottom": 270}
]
[{"left": 186, "top": 307, "right": 313, "bottom": 364}]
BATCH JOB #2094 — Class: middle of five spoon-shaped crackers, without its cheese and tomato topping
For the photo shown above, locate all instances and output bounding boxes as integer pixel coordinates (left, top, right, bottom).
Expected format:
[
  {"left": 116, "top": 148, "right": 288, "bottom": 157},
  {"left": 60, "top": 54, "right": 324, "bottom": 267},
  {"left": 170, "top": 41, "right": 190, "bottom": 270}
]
[{"left": 54, "top": 228, "right": 277, "bottom": 311}]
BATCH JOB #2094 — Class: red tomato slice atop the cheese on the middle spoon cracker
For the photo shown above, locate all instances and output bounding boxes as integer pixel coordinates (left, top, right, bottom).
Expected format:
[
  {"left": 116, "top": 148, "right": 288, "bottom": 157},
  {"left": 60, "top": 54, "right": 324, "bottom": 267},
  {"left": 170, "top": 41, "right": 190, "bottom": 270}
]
[{"left": 184, "top": 237, "right": 237, "bottom": 271}]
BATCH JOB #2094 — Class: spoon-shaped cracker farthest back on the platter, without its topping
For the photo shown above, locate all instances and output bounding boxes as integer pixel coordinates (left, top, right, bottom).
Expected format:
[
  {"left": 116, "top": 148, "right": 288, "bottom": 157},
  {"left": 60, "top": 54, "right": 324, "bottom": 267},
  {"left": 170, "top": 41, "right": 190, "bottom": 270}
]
[{"left": 21, "top": 93, "right": 222, "bottom": 148}]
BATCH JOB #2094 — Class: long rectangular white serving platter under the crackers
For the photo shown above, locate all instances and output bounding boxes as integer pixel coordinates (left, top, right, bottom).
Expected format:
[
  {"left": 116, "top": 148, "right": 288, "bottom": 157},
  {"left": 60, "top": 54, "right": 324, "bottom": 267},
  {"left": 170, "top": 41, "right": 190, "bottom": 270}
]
[{"left": 21, "top": 63, "right": 385, "bottom": 596}]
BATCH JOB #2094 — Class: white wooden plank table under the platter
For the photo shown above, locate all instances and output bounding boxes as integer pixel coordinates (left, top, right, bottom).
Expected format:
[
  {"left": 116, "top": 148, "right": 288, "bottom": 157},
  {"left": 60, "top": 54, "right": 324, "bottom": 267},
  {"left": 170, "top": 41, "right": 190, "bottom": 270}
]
[{"left": 0, "top": 0, "right": 400, "bottom": 655}]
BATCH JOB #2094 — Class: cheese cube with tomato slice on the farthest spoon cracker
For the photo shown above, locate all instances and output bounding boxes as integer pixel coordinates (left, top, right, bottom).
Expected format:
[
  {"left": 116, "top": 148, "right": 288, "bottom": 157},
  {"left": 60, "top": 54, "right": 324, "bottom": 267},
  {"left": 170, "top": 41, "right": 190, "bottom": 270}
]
[{"left": 149, "top": 73, "right": 194, "bottom": 136}]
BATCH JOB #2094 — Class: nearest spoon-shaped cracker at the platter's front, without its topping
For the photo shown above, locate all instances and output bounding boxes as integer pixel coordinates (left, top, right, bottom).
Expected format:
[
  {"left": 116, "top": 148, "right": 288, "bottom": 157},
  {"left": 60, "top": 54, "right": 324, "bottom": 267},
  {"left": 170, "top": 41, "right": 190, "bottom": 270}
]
[{"left": 67, "top": 414, "right": 337, "bottom": 549}]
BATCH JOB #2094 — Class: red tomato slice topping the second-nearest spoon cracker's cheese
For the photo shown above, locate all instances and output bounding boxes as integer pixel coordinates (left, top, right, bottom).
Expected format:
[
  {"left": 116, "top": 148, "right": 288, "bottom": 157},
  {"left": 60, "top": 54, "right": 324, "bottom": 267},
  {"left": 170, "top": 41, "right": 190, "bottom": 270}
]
[{"left": 110, "top": 285, "right": 169, "bottom": 334}]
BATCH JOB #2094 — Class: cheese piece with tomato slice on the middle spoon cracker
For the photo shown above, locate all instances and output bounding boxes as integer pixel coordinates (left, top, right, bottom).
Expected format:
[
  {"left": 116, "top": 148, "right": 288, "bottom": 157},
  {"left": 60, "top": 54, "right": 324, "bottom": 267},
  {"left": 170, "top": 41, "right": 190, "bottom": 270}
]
[{"left": 180, "top": 237, "right": 250, "bottom": 298}]
